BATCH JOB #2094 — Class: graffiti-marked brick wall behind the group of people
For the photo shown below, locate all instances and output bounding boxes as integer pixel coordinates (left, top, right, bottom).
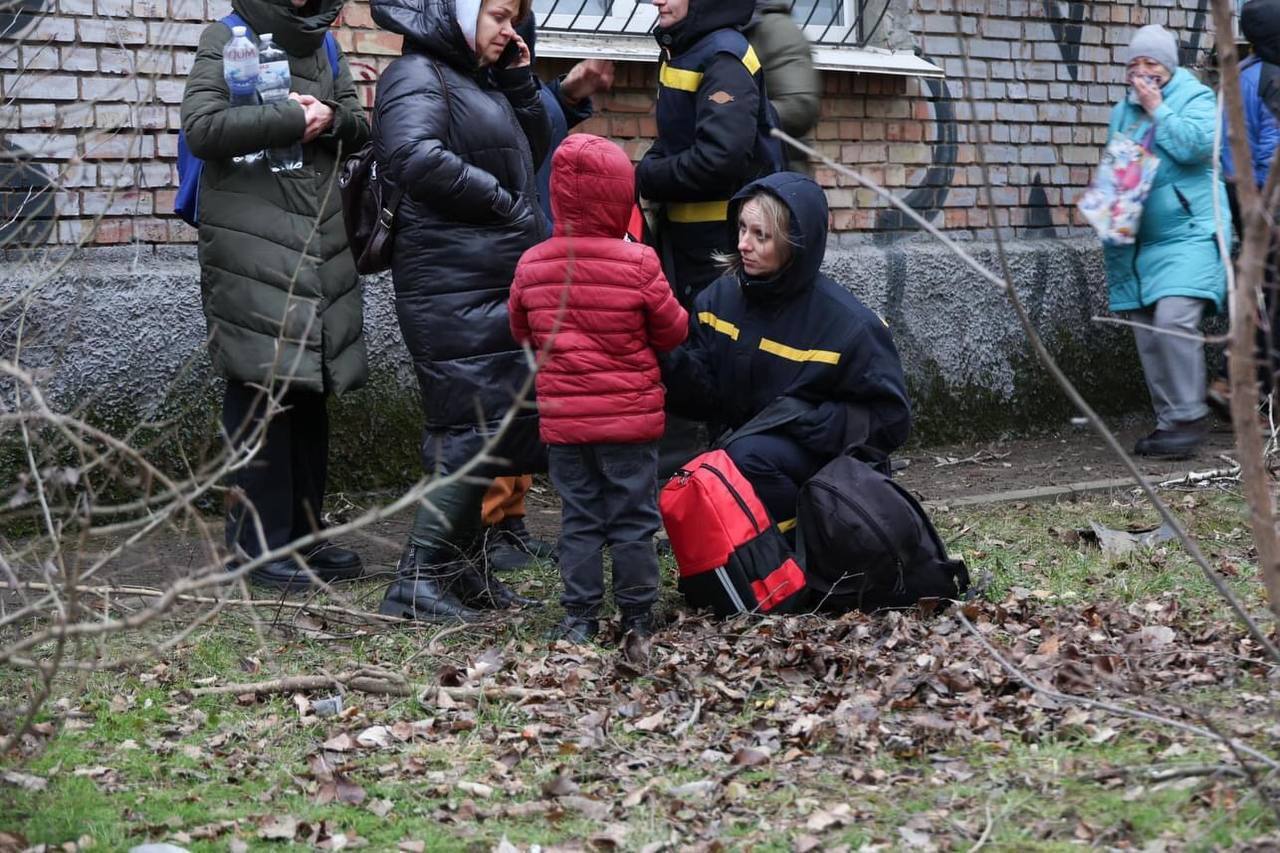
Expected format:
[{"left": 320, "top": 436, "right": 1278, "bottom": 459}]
[{"left": 0, "top": 0, "right": 1211, "bottom": 243}]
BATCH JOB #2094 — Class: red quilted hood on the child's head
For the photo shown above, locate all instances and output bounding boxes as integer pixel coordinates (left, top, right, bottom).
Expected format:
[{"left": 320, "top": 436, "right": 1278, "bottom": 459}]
[{"left": 552, "top": 133, "right": 636, "bottom": 238}]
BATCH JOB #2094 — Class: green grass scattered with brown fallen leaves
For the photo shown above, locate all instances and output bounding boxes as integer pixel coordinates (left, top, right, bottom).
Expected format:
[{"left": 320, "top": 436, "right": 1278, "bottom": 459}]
[{"left": 0, "top": 492, "right": 1276, "bottom": 850}]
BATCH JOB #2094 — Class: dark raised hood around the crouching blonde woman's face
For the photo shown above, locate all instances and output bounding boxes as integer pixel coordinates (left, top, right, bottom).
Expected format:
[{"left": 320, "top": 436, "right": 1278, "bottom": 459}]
[{"left": 728, "top": 172, "right": 828, "bottom": 302}]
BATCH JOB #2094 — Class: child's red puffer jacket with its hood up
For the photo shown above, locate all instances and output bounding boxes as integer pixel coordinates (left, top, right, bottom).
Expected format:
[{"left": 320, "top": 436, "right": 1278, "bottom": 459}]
[{"left": 508, "top": 133, "right": 689, "bottom": 444}]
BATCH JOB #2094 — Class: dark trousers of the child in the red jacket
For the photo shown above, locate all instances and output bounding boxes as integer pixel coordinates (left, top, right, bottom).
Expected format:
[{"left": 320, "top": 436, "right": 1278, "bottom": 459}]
[{"left": 550, "top": 442, "right": 662, "bottom": 619}]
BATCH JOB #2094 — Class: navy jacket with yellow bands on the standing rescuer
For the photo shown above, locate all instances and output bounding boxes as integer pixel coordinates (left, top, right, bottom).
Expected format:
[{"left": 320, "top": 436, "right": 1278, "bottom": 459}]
[{"left": 636, "top": 0, "right": 782, "bottom": 307}]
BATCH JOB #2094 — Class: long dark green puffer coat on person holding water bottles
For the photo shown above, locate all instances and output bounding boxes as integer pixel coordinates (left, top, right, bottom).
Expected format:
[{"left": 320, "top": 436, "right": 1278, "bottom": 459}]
[{"left": 182, "top": 0, "right": 369, "bottom": 393}]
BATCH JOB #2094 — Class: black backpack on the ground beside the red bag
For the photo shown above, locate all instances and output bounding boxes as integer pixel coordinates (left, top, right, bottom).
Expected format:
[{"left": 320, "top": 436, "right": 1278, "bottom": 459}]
[{"left": 796, "top": 456, "right": 969, "bottom": 612}]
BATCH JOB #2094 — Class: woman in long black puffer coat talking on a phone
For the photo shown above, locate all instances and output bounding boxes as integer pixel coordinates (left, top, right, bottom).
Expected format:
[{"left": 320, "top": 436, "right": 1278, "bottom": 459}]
[{"left": 372, "top": 0, "right": 550, "bottom": 620}]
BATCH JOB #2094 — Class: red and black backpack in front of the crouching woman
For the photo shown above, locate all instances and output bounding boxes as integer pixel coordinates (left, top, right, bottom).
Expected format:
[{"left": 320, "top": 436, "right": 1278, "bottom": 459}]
[{"left": 658, "top": 451, "right": 806, "bottom": 616}]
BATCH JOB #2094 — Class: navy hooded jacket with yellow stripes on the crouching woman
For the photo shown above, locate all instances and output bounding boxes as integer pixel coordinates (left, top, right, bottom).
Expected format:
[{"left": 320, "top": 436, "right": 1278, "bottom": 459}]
[{"left": 663, "top": 172, "right": 911, "bottom": 457}]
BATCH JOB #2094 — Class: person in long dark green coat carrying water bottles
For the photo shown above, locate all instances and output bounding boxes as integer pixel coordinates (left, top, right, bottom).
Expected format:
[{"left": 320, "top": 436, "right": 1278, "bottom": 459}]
[{"left": 182, "top": 0, "right": 369, "bottom": 588}]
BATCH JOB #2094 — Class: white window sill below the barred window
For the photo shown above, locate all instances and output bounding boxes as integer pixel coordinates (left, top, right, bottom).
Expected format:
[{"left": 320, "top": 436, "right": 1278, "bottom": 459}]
[{"left": 538, "top": 29, "right": 943, "bottom": 78}]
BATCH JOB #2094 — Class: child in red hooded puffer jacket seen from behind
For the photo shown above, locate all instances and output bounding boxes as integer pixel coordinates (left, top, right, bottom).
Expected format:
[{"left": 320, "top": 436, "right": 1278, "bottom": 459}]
[{"left": 508, "top": 133, "right": 689, "bottom": 643}]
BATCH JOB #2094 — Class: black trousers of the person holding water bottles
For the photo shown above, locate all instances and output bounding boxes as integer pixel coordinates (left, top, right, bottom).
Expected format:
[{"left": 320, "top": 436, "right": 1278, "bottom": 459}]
[{"left": 223, "top": 379, "right": 329, "bottom": 557}]
